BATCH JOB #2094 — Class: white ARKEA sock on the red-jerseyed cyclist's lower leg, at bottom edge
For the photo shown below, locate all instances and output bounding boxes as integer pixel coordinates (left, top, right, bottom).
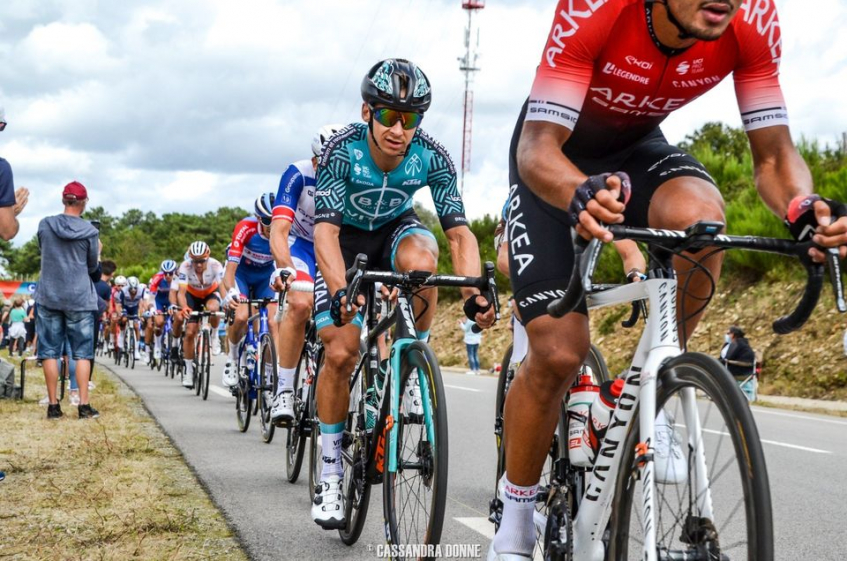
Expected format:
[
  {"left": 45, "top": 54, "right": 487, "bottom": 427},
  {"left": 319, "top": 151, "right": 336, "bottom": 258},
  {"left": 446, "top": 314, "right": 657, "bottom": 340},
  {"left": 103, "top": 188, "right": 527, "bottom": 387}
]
[{"left": 494, "top": 474, "right": 538, "bottom": 555}]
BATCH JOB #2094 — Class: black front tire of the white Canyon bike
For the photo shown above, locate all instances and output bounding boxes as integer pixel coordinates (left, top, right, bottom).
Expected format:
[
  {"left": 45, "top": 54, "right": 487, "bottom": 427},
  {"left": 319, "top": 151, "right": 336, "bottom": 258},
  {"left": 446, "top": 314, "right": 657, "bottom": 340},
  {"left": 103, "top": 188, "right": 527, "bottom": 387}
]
[{"left": 607, "top": 353, "right": 774, "bottom": 561}]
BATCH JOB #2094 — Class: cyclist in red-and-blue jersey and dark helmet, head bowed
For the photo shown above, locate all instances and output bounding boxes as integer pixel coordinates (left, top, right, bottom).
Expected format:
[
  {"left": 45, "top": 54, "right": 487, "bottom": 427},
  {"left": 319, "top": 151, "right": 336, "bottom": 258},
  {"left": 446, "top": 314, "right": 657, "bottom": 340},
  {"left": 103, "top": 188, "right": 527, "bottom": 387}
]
[{"left": 223, "top": 193, "right": 276, "bottom": 387}]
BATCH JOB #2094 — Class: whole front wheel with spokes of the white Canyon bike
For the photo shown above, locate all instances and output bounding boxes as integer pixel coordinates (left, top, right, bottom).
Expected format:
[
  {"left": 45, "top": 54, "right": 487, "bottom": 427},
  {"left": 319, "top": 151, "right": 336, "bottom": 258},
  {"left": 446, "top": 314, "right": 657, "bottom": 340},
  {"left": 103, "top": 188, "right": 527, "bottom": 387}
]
[{"left": 607, "top": 353, "right": 774, "bottom": 561}]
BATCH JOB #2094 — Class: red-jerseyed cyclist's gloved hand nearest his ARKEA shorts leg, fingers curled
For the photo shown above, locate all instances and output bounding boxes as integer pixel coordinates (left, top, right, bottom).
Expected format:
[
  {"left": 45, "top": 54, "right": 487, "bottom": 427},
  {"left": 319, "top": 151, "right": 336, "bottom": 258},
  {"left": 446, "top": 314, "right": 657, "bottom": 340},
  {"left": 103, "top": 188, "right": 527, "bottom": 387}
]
[{"left": 568, "top": 171, "right": 630, "bottom": 242}]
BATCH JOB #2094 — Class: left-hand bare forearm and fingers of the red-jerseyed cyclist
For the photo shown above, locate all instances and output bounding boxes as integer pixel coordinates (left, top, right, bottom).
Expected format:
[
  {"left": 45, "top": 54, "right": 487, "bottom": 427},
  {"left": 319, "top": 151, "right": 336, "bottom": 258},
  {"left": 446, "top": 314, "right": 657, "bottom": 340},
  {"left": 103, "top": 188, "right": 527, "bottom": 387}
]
[{"left": 517, "top": 121, "right": 624, "bottom": 242}]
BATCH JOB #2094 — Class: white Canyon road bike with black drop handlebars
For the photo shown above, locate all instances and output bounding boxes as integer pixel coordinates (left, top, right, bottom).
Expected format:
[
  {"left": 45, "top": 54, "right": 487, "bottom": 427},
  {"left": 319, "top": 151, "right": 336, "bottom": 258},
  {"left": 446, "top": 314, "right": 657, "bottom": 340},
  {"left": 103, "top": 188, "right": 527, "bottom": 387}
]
[{"left": 535, "top": 222, "right": 845, "bottom": 561}]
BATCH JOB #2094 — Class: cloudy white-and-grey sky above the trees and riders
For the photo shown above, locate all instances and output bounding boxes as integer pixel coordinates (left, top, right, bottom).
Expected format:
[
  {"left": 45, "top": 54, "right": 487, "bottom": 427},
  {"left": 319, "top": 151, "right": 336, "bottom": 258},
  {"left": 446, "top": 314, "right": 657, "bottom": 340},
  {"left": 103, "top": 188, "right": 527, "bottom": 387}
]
[{"left": 0, "top": 0, "right": 847, "bottom": 243}]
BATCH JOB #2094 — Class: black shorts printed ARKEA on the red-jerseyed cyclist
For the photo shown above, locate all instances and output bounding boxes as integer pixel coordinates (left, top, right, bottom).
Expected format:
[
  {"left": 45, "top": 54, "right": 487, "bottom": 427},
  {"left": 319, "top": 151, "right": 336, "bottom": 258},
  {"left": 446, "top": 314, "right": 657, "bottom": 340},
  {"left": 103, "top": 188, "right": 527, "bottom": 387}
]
[{"left": 507, "top": 100, "right": 715, "bottom": 325}]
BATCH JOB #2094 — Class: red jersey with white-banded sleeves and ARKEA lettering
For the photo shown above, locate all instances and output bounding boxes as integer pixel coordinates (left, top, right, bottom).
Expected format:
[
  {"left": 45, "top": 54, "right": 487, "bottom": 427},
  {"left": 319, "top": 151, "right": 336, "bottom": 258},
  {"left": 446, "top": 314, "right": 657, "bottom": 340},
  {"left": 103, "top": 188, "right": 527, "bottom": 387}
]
[{"left": 526, "top": 0, "right": 788, "bottom": 152}]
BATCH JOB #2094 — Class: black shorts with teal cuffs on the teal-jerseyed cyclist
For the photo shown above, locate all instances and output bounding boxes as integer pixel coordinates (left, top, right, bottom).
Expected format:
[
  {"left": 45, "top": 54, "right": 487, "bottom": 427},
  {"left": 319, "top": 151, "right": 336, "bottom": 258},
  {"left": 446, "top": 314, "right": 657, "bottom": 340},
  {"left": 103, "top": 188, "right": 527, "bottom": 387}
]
[{"left": 315, "top": 210, "right": 435, "bottom": 330}]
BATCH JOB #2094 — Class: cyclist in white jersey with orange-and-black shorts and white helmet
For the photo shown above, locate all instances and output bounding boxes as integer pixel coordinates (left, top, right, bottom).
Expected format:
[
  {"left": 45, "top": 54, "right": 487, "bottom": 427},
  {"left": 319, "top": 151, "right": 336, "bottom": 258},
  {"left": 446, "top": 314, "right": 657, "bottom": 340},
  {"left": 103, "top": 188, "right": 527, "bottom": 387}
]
[{"left": 171, "top": 241, "right": 226, "bottom": 388}]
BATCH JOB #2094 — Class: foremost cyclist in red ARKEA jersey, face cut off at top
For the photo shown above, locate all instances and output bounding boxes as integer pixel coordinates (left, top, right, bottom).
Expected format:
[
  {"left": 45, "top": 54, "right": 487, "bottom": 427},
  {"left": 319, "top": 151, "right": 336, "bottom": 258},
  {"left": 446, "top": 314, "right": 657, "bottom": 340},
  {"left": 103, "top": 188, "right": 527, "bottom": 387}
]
[{"left": 489, "top": 0, "right": 847, "bottom": 560}]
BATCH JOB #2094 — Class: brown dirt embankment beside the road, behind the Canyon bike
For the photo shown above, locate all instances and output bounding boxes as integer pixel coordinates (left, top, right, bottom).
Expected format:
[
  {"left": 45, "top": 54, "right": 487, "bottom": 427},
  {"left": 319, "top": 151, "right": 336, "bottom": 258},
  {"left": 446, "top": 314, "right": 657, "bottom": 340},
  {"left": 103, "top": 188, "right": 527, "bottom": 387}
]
[{"left": 431, "top": 282, "right": 847, "bottom": 400}]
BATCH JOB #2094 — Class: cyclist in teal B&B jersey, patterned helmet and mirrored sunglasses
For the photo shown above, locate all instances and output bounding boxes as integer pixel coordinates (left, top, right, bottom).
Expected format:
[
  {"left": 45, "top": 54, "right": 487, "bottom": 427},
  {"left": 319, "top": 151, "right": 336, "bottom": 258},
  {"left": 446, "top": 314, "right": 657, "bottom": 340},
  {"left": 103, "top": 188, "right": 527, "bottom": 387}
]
[{"left": 312, "top": 59, "right": 494, "bottom": 528}]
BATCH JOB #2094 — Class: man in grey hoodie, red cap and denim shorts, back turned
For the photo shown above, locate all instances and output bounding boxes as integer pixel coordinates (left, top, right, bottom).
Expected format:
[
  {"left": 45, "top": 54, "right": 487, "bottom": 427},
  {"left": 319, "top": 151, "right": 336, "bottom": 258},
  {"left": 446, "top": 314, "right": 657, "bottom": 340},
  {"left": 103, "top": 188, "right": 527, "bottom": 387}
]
[{"left": 35, "top": 181, "right": 100, "bottom": 419}]
